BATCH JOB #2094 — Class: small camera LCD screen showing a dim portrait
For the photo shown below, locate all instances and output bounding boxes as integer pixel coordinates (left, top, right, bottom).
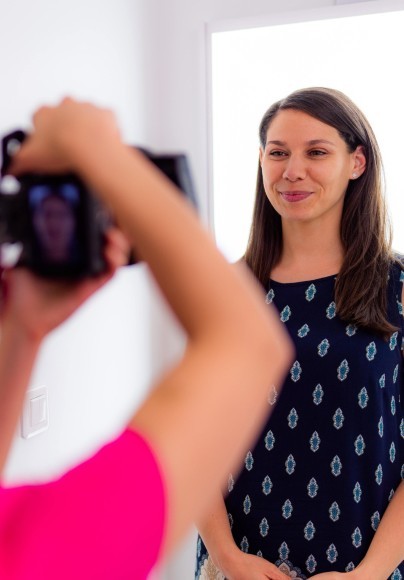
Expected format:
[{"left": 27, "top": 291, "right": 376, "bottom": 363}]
[{"left": 27, "top": 178, "right": 85, "bottom": 276}]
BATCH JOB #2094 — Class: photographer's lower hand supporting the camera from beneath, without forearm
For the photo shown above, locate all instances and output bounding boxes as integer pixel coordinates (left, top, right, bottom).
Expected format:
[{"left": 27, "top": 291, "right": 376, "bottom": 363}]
[{"left": 0, "top": 228, "right": 129, "bottom": 342}]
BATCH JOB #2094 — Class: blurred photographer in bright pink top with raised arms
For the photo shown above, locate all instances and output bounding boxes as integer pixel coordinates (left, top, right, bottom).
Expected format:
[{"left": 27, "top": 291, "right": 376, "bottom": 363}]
[{"left": 0, "top": 99, "right": 291, "bottom": 580}]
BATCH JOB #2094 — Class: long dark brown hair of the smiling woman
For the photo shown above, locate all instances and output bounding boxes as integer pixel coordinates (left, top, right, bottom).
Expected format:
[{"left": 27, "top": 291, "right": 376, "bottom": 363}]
[{"left": 244, "top": 87, "right": 396, "bottom": 335}]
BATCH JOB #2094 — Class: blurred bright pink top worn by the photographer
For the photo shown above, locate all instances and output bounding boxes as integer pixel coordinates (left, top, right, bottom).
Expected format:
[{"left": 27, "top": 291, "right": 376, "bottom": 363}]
[{"left": 0, "top": 430, "right": 165, "bottom": 580}]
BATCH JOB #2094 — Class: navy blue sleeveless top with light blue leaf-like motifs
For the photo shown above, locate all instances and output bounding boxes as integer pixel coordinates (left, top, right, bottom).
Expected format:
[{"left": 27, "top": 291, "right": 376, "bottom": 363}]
[{"left": 196, "top": 265, "right": 404, "bottom": 580}]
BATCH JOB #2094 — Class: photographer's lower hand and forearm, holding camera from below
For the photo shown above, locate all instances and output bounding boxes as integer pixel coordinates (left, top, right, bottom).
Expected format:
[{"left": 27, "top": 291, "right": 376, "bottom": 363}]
[{"left": 0, "top": 229, "right": 127, "bottom": 473}]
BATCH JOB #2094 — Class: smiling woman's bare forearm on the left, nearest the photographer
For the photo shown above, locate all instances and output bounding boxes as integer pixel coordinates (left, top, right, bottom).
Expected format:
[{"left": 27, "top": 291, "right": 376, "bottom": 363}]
[{"left": 198, "top": 492, "right": 288, "bottom": 580}]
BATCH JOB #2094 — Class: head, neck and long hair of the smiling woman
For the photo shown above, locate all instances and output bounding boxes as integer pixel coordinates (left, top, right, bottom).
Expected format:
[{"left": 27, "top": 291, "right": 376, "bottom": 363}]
[{"left": 246, "top": 88, "right": 392, "bottom": 332}]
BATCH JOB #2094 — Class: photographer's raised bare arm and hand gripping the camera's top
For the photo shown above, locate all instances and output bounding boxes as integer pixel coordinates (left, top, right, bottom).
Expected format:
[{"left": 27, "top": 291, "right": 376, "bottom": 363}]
[{"left": 14, "top": 100, "right": 291, "bottom": 551}]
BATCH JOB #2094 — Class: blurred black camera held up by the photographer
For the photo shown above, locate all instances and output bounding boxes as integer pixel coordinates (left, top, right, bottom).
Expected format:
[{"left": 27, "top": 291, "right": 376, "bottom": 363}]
[{"left": 0, "top": 130, "right": 196, "bottom": 279}]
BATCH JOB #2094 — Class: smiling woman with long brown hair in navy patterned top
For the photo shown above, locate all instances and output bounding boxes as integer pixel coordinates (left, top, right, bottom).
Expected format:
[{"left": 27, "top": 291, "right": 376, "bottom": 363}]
[{"left": 197, "top": 87, "right": 404, "bottom": 580}]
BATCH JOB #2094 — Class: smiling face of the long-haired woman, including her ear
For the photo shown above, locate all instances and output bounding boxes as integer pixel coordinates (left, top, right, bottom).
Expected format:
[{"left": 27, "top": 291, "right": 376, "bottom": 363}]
[{"left": 260, "top": 109, "right": 366, "bottom": 224}]
